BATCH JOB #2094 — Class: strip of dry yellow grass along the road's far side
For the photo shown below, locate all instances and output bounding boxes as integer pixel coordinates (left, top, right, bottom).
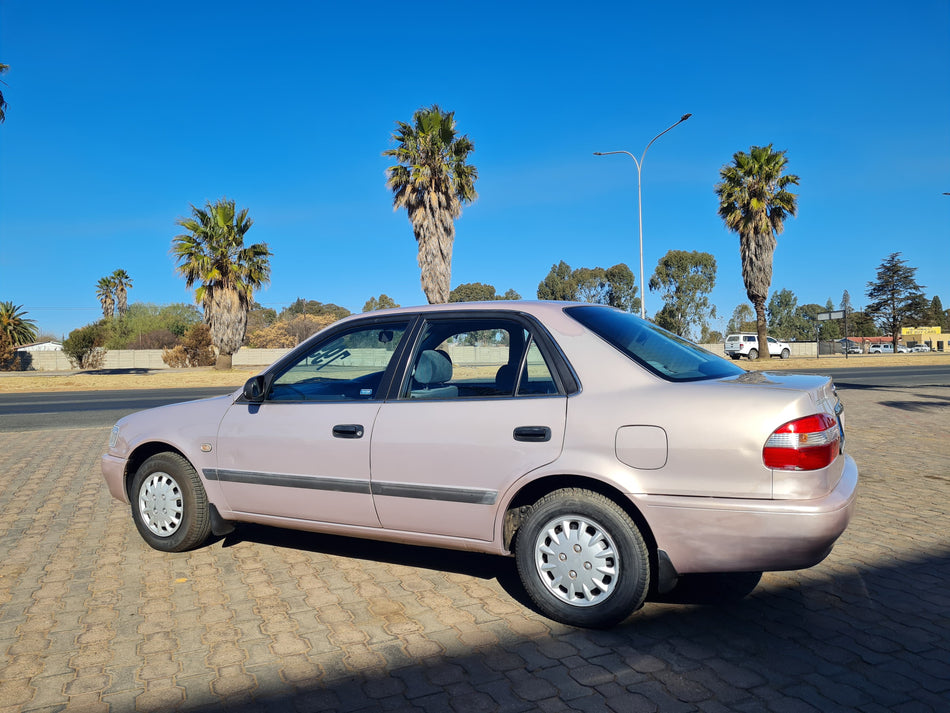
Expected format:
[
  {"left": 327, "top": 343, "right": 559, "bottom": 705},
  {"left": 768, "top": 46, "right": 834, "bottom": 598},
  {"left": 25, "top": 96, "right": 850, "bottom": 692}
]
[{"left": 0, "top": 354, "right": 950, "bottom": 393}]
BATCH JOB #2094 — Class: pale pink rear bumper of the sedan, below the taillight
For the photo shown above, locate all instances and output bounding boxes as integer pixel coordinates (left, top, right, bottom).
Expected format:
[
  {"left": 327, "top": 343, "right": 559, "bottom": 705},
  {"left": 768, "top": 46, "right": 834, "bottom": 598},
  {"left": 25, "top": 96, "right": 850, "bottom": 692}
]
[{"left": 633, "top": 455, "right": 858, "bottom": 574}]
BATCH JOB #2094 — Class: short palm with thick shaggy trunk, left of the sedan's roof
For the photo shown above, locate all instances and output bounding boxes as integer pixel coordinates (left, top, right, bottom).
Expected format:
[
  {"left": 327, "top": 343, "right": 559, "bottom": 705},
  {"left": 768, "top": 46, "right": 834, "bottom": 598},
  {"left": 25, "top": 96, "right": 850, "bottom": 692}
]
[{"left": 172, "top": 198, "right": 271, "bottom": 369}]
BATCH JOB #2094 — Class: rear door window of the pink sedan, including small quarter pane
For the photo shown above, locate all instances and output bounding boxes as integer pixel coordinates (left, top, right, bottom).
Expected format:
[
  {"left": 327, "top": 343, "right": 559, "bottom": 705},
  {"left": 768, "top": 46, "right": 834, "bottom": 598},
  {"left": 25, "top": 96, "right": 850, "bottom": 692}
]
[{"left": 401, "top": 318, "right": 557, "bottom": 400}]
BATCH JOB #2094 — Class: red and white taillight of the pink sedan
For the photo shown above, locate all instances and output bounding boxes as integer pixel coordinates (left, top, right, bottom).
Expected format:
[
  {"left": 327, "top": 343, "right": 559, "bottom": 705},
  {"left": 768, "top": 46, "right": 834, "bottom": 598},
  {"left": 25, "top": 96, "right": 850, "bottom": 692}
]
[{"left": 762, "top": 413, "right": 841, "bottom": 470}]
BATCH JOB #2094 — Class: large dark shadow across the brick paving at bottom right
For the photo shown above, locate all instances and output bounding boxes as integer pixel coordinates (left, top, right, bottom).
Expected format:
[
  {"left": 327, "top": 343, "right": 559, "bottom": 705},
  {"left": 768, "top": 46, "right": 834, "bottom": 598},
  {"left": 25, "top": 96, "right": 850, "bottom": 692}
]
[{"left": 165, "top": 543, "right": 950, "bottom": 713}]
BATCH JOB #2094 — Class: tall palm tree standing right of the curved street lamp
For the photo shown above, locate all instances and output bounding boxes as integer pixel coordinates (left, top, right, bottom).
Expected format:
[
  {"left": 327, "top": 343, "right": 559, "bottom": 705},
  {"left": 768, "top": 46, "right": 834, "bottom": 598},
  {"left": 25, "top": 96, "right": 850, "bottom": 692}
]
[{"left": 716, "top": 144, "right": 798, "bottom": 359}]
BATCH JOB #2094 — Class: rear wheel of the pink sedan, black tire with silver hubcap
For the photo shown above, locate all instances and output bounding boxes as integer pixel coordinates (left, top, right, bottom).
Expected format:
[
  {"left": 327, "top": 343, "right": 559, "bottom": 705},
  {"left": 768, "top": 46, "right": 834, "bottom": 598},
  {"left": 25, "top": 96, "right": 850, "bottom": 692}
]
[{"left": 515, "top": 488, "right": 650, "bottom": 628}]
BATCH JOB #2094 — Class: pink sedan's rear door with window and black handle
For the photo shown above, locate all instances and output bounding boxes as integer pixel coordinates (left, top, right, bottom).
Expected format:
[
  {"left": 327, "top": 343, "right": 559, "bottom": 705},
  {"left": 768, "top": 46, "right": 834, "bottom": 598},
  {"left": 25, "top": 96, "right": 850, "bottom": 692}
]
[{"left": 372, "top": 317, "right": 567, "bottom": 540}]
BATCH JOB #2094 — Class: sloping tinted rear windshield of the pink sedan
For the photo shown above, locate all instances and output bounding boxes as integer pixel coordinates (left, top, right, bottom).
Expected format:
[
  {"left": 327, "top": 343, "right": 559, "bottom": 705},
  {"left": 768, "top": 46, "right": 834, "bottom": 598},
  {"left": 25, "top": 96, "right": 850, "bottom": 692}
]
[{"left": 565, "top": 305, "right": 744, "bottom": 381}]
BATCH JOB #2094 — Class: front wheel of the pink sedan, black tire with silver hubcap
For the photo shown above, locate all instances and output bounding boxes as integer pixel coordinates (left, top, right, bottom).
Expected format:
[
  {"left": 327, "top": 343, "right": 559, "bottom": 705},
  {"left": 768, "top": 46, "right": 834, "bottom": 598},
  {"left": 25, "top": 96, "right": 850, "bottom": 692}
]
[{"left": 130, "top": 453, "right": 211, "bottom": 552}]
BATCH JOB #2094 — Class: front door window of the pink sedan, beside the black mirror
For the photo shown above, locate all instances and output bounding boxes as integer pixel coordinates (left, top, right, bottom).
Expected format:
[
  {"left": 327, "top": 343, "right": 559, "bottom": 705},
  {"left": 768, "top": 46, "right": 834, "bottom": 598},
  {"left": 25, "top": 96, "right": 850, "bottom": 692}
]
[{"left": 268, "top": 322, "right": 408, "bottom": 401}]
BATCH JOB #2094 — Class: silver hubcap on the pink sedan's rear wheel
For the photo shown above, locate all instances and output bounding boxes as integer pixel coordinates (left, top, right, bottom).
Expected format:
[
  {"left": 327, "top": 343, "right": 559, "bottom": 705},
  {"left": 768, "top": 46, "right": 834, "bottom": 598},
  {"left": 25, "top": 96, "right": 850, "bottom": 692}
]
[{"left": 534, "top": 515, "right": 620, "bottom": 607}]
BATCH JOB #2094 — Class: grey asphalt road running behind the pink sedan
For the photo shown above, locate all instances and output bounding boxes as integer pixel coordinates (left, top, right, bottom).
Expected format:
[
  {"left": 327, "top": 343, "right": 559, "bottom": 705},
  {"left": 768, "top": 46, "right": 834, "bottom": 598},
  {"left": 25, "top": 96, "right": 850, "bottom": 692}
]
[{"left": 0, "top": 360, "right": 950, "bottom": 433}]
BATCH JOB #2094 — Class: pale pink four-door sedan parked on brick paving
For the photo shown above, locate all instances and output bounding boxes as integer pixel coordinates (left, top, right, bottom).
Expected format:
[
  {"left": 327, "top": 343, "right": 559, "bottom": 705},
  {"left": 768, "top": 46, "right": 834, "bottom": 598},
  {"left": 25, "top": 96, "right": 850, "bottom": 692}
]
[{"left": 102, "top": 302, "right": 858, "bottom": 627}]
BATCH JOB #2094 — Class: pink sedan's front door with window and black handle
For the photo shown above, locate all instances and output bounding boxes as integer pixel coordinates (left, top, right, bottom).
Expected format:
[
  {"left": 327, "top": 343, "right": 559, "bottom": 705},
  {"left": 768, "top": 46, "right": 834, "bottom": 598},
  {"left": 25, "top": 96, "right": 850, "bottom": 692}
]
[{"left": 212, "top": 321, "right": 407, "bottom": 527}]
